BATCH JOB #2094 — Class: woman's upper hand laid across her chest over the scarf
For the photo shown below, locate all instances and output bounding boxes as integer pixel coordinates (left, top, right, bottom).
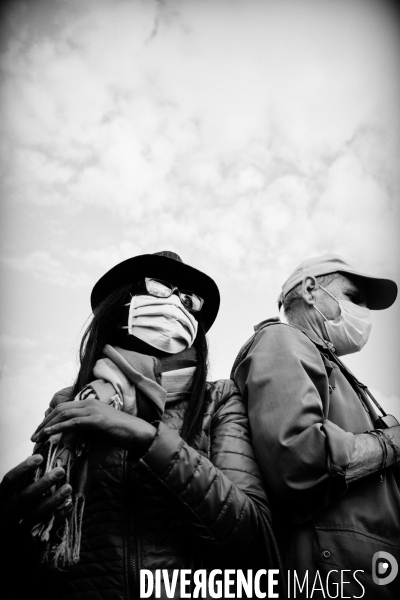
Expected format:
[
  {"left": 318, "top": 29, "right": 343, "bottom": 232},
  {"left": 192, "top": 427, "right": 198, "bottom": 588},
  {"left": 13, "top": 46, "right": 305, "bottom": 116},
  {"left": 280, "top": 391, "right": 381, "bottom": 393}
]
[{"left": 31, "top": 399, "right": 157, "bottom": 452}]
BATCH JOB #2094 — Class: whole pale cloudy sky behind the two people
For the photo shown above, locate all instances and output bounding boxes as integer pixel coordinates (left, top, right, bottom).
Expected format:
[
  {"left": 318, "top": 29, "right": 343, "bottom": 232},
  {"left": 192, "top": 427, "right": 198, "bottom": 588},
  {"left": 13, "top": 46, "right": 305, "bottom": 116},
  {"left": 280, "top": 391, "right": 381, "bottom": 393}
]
[{"left": 0, "top": 0, "right": 400, "bottom": 473}]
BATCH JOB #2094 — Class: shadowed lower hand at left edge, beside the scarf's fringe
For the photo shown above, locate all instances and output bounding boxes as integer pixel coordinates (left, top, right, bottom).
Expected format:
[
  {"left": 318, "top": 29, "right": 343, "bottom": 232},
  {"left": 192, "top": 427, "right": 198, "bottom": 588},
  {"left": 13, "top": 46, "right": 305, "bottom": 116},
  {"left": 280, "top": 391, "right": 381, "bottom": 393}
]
[{"left": 0, "top": 454, "right": 72, "bottom": 534}]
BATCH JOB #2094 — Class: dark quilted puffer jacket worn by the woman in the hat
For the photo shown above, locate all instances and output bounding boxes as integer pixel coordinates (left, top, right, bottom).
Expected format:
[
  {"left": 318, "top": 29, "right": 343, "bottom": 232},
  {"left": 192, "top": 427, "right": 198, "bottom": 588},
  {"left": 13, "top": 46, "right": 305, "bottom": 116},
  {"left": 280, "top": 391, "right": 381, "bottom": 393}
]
[{"left": 36, "top": 380, "right": 278, "bottom": 600}]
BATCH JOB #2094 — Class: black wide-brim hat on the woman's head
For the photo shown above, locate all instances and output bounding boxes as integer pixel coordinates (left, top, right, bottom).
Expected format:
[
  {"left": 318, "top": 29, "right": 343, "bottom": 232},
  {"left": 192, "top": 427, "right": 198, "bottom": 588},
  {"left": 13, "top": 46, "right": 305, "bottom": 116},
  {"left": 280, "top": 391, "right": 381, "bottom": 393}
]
[{"left": 90, "top": 250, "right": 220, "bottom": 331}]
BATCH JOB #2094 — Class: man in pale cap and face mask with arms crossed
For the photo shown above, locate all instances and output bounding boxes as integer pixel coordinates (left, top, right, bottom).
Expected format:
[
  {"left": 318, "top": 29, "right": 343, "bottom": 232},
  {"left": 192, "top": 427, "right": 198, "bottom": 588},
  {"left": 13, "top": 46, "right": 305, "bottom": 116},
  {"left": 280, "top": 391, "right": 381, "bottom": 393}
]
[{"left": 232, "top": 254, "right": 400, "bottom": 600}]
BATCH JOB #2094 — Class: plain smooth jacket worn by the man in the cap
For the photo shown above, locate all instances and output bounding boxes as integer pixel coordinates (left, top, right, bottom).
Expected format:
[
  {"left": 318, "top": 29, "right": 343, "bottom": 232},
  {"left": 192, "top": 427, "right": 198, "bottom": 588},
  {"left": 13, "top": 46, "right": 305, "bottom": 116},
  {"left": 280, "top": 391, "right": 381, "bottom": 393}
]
[{"left": 234, "top": 322, "right": 400, "bottom": 600}]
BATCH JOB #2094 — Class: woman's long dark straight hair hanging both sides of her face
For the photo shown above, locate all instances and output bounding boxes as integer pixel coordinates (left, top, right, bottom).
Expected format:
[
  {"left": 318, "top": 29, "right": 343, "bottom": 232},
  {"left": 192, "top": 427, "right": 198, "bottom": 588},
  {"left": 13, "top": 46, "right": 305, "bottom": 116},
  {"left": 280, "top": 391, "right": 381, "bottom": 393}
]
[{"left": 72, "top": 284, "right": 208, "bottom": 445}]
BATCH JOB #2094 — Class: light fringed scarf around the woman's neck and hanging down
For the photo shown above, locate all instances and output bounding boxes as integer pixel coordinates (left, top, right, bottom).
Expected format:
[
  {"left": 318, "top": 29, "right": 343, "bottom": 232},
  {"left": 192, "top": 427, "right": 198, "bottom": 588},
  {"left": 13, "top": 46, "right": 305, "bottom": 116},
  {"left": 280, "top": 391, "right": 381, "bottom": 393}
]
[{"left": 32, "top": 344, "right": 167, "bottom": 569}]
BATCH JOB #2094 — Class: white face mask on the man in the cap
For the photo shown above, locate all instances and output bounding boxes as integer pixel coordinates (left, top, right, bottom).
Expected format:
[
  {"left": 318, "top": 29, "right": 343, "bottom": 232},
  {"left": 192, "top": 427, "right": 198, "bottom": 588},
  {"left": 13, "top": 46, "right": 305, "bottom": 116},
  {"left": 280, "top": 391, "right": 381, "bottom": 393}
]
[{"left": 314, "top": 285, "right": 372, "bottom": 356}]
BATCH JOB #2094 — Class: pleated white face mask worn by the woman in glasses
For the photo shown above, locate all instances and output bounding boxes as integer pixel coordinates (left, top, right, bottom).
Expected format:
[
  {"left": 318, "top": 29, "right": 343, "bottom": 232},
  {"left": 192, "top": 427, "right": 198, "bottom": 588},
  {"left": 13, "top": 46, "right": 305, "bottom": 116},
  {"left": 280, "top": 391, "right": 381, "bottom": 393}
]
[{"left": 123, "top": 294, "right": 198, "bottom": 354}]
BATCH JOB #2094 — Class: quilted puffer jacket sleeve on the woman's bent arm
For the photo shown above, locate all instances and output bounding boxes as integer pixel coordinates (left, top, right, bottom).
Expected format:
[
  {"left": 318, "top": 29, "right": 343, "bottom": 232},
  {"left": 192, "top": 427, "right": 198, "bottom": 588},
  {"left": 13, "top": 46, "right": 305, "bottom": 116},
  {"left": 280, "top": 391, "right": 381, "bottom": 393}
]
[{"left": 138, "top": 381, "right": 276, "bottom": 567}]
